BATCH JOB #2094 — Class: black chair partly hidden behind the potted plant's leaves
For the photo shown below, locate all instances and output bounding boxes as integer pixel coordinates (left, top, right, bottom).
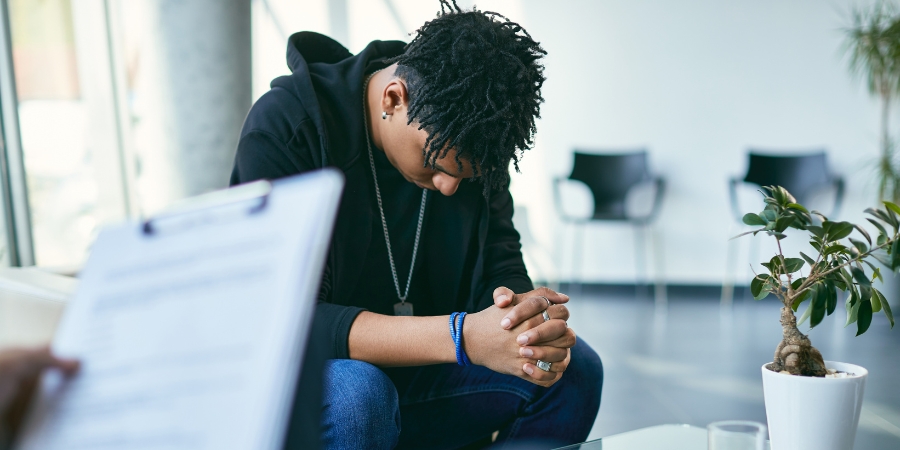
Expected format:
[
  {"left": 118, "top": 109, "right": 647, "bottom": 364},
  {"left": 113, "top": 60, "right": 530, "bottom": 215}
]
[{"left": 720, "top": 149, "right": 844, "bottom": 305}]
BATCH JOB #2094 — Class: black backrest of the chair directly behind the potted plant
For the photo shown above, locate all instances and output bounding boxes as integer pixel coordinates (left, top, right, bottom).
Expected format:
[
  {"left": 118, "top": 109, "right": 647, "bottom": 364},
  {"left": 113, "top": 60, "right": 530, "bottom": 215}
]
[{"left": 744, "top": 150, "right": 834, "bottom": 203}]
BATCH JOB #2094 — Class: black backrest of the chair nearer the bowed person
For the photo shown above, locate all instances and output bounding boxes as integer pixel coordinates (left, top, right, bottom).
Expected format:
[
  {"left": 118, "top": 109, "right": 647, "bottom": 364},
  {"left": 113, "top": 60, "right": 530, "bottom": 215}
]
[{"left": 569, "top": 150, "right": 651, "bottom": 220}]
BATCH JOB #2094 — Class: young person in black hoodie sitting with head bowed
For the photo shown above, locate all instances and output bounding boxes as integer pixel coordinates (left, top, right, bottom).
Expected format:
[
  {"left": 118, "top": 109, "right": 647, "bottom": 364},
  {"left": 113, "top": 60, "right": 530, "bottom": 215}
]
[{"left": 231, "top": 0, "right": 603, "bottom": 448}]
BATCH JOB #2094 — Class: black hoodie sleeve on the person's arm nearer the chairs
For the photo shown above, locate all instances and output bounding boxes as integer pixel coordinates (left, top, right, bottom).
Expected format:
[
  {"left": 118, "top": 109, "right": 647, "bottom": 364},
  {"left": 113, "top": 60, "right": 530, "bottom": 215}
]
[{"left": 475, "top": 187, "right": 534, "bottom": 311}]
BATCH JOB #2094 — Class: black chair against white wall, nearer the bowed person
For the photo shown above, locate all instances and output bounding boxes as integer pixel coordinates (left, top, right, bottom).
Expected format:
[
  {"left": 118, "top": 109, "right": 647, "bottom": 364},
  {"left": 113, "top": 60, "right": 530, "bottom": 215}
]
[{"left": 553, "top": 150, "right": 666, "bottom": 302}]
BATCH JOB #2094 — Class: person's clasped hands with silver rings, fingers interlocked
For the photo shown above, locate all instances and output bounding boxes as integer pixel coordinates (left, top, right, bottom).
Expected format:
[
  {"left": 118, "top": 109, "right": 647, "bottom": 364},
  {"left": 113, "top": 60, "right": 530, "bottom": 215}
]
[{"left": 464, "top": 287, "right": 575, "bottom": 387}]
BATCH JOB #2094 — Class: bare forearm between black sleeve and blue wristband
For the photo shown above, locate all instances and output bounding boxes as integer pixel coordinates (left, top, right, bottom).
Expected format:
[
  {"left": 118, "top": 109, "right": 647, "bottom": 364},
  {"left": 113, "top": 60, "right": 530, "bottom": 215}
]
[{"left": 349, "top": 311, "right": 456, "bottom": 367}]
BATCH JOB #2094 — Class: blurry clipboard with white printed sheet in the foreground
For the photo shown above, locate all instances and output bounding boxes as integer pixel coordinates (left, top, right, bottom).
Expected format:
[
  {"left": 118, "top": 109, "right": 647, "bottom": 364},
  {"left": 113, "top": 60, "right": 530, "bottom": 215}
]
[{"left": 14, "top": 169, "right": 344, "bottom": 450}]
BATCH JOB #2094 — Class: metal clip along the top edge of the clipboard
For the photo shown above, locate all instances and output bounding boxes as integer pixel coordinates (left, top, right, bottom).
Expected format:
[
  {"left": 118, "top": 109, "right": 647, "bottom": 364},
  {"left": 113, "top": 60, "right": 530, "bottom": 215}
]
[{"left": 141, "top": 180, "right": 272, "bottom": 236}]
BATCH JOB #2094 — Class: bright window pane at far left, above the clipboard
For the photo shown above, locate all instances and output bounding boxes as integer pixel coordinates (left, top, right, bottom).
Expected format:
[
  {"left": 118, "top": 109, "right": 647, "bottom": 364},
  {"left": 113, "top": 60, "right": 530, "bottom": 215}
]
[{"left": 10, "top": 0, "right": 125, "bottom": 266}]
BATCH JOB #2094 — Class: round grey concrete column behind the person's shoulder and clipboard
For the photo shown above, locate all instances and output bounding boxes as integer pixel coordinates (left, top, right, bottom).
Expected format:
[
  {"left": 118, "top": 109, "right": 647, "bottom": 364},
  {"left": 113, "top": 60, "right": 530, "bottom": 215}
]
[{"left": 133, "top": 0, "right": 252, "bottom": 213}]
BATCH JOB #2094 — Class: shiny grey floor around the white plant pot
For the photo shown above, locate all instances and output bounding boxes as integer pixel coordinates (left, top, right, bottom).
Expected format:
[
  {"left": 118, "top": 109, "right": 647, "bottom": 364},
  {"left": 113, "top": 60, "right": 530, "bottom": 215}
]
[{"left": 561, "top": 285, "right": 900, "bottom": 450}]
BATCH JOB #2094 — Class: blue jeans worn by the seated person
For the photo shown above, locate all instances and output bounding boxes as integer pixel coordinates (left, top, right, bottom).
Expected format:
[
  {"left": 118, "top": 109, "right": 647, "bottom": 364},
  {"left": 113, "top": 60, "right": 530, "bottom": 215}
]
[{"left": 322, "top": 340, "right": 603, "bottom": 449}]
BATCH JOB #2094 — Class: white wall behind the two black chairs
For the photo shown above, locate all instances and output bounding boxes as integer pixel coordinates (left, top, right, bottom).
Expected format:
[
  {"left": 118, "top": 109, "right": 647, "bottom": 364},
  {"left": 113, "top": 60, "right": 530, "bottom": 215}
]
[{"left": 254, "top": 0, "right": 877, "bottom": 284}]
